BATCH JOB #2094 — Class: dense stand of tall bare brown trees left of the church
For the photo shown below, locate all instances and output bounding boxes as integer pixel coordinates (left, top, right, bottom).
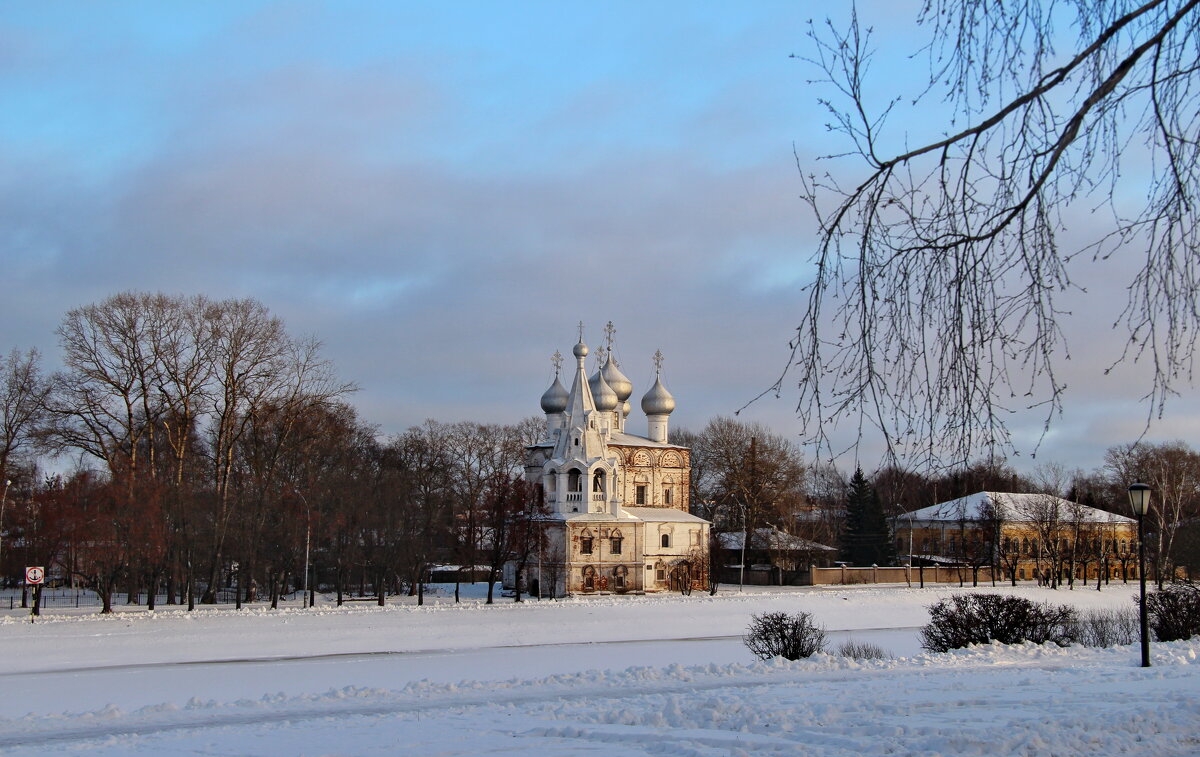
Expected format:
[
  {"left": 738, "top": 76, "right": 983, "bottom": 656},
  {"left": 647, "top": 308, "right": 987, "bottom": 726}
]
[{"left": 0, "top": 293, "right": 541, "bottom": 611}]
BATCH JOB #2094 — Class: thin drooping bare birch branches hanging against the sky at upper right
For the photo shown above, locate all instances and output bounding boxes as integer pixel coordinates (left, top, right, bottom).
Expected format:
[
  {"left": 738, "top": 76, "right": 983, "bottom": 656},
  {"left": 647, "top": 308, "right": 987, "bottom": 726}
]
[{"left": 776, "top": 0, "right": 1200, "bottom": 464}]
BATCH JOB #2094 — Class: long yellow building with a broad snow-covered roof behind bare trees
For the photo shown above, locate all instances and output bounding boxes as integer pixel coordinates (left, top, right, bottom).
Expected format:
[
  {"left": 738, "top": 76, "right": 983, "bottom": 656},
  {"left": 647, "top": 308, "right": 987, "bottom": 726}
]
[{"left": 892, "top": 492, "right": 1138, "bottom": 583}]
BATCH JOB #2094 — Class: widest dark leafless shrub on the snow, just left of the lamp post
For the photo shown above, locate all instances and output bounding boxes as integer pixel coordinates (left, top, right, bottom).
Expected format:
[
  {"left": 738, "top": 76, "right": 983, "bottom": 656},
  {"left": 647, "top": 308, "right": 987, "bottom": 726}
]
[{"left": 920, "top": 594, "right": 1078, "bottom": 651}]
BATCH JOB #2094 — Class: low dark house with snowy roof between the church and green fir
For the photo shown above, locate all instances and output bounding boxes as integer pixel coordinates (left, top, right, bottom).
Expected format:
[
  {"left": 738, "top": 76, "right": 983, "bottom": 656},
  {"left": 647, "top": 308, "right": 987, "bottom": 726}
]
[{"left": 716, "top": 527, "right": 838, "bottom": 584}]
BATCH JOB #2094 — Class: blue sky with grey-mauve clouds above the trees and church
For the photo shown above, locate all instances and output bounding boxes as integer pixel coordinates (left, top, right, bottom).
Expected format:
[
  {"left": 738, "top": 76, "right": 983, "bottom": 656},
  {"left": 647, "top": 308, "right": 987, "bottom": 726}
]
[{"left": 0, "top": 0, "right": 1200, "bottom": 475}]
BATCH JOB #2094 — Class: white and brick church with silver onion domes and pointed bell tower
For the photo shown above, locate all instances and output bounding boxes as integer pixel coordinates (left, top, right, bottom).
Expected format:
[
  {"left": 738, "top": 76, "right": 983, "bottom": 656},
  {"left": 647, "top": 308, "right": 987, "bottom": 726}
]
[{"left": 505, "top": 323, "right": 709, "bottom": 596}]
